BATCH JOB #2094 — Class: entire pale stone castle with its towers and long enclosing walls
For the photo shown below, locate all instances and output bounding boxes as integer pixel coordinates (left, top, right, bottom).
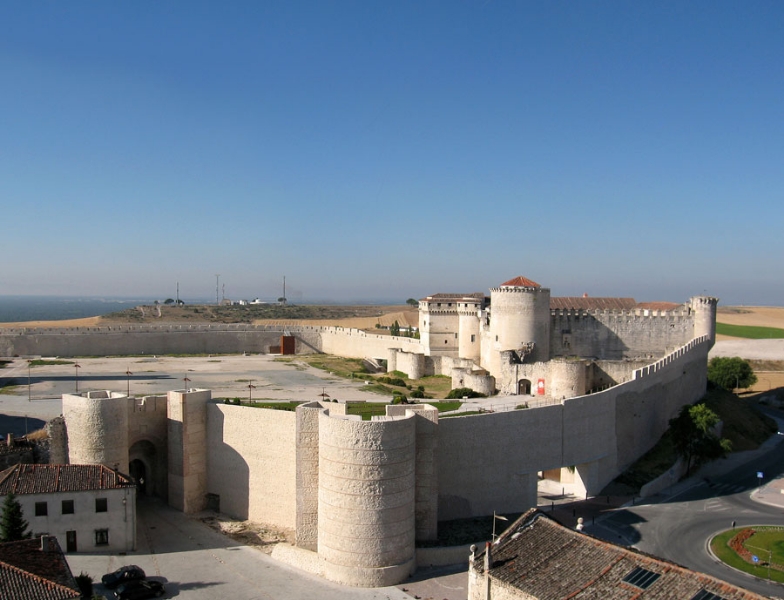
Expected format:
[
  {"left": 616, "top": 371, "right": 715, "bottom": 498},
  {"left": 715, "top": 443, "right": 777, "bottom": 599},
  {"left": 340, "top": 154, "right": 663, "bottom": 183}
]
[{"left": 0, "top": 278, "right": 718, "bottom": 586}]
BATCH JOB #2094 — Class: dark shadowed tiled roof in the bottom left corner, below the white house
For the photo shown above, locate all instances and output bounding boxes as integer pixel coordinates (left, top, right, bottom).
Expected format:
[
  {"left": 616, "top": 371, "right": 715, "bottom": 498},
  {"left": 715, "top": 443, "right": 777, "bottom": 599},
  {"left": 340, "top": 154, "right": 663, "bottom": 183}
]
[{"left": 0, "top": 537, "right": 81, "bottom": 600}]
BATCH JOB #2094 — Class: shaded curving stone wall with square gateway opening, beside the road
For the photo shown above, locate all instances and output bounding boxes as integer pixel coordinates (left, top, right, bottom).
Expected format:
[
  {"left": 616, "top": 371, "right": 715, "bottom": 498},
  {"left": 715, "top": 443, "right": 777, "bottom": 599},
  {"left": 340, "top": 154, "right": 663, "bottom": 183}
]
[{"left": 437, "top": 338, "right": 711, "bottom": 520}]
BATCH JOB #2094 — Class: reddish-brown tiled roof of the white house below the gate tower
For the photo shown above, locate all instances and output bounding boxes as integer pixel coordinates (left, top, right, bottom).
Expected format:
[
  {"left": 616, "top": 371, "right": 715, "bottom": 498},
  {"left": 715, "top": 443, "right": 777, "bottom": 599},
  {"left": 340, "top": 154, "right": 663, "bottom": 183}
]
[{"left": 0, "top": 464, "right": 134, "bottom": 496}]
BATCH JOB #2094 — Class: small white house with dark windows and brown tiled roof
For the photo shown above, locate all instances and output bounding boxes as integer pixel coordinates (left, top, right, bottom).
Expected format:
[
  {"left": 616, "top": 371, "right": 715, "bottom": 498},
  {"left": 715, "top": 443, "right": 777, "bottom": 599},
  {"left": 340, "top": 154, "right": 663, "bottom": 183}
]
[{"left": 0, "top": 464, "right": 136, "bottom": 552}]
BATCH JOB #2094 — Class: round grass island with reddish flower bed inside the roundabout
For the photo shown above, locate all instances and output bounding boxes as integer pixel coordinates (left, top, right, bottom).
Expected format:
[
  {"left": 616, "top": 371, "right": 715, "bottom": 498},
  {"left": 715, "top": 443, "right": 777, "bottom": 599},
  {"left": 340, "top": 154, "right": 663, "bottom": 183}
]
[{"left": 710, "top": 527, "right": 784, "bottom": 583}]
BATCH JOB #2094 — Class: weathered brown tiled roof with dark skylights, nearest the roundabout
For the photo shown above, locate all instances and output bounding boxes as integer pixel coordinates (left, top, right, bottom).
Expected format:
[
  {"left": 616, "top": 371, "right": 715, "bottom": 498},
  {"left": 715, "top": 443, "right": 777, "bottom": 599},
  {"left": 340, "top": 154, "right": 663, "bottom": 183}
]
[{"left": 478, "top": 509, "right": 765, "bottom": 600}]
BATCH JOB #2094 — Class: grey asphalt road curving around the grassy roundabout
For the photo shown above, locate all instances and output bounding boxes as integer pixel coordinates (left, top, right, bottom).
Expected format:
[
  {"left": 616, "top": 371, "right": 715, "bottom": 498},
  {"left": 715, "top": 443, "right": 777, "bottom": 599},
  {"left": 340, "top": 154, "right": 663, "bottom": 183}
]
[{"left": 590, "top": 428, "right": 784, "bottom": 598}]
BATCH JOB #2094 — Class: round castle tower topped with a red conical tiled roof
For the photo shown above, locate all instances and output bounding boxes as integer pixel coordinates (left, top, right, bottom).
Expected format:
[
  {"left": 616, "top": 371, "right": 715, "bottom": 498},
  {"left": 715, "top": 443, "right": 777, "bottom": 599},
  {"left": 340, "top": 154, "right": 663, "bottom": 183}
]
[{"left": 490, "top": 277, "right": 550, "bottom": 362}]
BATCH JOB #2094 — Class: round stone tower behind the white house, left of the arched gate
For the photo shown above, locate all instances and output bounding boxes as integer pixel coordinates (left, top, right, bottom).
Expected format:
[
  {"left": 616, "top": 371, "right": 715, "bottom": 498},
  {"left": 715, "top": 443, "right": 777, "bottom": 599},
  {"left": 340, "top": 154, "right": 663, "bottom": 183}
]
[{"left": 63, "top": 391, "right": 129, "bottom": 473}]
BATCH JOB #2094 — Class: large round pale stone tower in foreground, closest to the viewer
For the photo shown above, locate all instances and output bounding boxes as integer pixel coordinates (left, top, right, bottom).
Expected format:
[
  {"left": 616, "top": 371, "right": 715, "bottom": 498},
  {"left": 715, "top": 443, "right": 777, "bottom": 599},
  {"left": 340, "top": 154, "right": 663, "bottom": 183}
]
[{"left": 318, "top": 411, "right": 416, "bottom": 587}]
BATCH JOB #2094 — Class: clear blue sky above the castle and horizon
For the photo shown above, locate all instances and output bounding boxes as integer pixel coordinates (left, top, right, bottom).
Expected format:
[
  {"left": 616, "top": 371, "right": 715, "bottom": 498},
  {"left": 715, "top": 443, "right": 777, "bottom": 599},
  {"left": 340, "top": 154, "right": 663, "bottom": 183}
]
[{"left": 0, "top": 0, "right": 784, "bottom": 305}]
